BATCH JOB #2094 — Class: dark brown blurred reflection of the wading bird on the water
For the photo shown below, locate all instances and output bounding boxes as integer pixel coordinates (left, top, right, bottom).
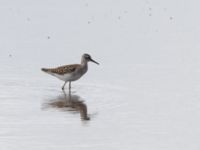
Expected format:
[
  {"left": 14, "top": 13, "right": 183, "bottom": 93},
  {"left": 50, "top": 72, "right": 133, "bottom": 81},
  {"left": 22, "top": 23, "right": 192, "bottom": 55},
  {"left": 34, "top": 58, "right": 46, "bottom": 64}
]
[{"left": 45, "top": 90, "right": 90, "bottom": 120}]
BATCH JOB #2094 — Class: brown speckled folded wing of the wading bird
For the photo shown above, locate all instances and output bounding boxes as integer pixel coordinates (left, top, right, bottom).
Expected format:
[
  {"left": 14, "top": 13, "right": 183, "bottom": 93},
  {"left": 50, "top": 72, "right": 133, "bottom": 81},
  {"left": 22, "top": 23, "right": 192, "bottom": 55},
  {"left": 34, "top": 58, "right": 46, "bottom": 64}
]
[{"left": 42, "top": 64, "right": 79, "bottom": 75}]
